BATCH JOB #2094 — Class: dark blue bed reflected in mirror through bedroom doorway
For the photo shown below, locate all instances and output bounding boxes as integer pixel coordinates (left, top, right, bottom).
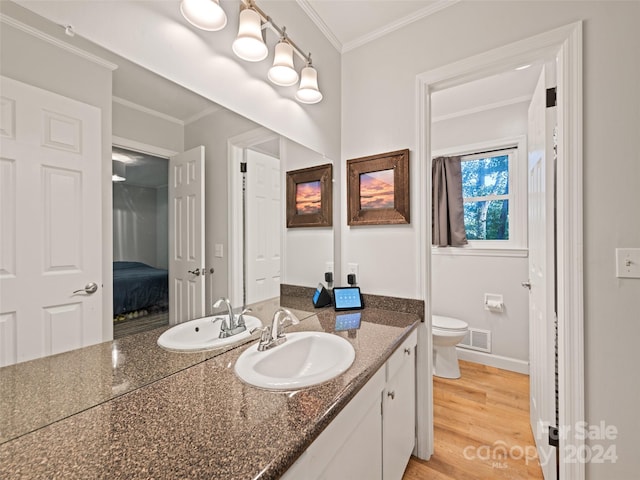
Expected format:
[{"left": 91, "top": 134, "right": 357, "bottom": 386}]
[{"left": 113, "top": 262, "right": 169, "bottom": 319}]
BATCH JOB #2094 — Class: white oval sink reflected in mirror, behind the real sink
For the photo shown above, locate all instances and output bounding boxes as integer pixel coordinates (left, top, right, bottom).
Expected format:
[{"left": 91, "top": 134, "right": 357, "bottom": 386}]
[{"left": 158, "top": 314, "right": 262, "bottom": 352}]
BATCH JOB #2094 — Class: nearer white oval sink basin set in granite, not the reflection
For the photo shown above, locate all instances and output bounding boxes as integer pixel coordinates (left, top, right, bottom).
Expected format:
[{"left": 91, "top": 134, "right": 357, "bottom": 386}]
[{"left": 235, "top": 332, "right": 356, "bottom": 390}]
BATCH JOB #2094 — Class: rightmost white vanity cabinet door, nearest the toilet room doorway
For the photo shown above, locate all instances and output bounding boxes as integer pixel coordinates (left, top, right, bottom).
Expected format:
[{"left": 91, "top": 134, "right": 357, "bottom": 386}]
[{"left": 382, "top": 340, "right": 416, "bottom": 480}]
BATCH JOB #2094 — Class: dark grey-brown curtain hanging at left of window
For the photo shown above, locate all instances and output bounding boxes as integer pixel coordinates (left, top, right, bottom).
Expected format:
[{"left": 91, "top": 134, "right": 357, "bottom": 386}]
[{"left": 431, "top": 157, "right": 467, "bottom": 247}]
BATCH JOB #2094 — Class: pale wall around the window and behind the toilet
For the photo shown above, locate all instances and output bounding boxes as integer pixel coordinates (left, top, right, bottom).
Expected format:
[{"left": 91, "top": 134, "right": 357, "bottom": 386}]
[{"left": 431, "top": 101, "right": 529, "bottom": 371}]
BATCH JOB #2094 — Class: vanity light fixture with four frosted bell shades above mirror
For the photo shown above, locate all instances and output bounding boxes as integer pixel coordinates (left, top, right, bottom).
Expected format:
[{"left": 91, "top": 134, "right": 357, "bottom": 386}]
[{"left": 180, "top": 0, "right": 322, "bottom": 104}]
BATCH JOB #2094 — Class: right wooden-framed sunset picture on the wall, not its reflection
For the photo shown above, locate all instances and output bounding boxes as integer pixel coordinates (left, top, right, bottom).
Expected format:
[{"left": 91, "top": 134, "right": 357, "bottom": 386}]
[{"left": 347, "top": 149, "right": 411, "bottom": 225}]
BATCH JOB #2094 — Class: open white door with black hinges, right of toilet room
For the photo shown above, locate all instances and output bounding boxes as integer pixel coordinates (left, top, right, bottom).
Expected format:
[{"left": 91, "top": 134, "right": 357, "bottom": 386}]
[{"left": 528, "top": 69, "right": 556, "bottom": 480}]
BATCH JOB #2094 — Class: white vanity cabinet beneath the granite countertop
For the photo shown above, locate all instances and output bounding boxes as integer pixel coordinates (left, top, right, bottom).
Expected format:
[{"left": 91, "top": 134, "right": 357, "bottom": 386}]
[{"left": 281, "top": 330, "right": 417, "bottom": 480}]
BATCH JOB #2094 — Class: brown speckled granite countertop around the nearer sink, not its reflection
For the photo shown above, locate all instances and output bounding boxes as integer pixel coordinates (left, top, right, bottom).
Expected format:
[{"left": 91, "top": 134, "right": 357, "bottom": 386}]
[{"left": 0, "top": 308, "right": 420, "bottom": 480}]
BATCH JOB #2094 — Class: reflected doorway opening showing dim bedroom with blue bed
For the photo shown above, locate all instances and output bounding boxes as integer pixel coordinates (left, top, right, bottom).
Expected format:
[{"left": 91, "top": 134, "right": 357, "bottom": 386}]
[{"left": 112, "top": 147, "right": 169, "bottom": 338}]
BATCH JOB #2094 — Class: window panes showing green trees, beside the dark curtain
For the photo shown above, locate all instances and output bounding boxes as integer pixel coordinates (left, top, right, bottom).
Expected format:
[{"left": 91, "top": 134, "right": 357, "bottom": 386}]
[{"left": 461, "top": 150, "right": 515, "bottom": 241}]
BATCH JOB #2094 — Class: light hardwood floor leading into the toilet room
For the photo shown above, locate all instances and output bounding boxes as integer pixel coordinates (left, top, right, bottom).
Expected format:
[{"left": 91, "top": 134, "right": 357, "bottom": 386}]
[{"left": 402, "top": 361, "right": 543, "bottom": 480}]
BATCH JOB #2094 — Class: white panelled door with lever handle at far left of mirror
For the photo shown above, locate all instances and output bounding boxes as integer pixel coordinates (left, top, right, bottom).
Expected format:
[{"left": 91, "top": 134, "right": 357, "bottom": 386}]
[{"left": 0, "top": 77, "right": 103, "bottom": 366}]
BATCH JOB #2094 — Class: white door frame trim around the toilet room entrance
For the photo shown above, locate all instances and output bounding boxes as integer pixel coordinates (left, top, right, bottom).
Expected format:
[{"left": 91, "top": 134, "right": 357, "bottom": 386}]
[{"left": 417, "top": 22, "right": 584, "bottom": 478}]
